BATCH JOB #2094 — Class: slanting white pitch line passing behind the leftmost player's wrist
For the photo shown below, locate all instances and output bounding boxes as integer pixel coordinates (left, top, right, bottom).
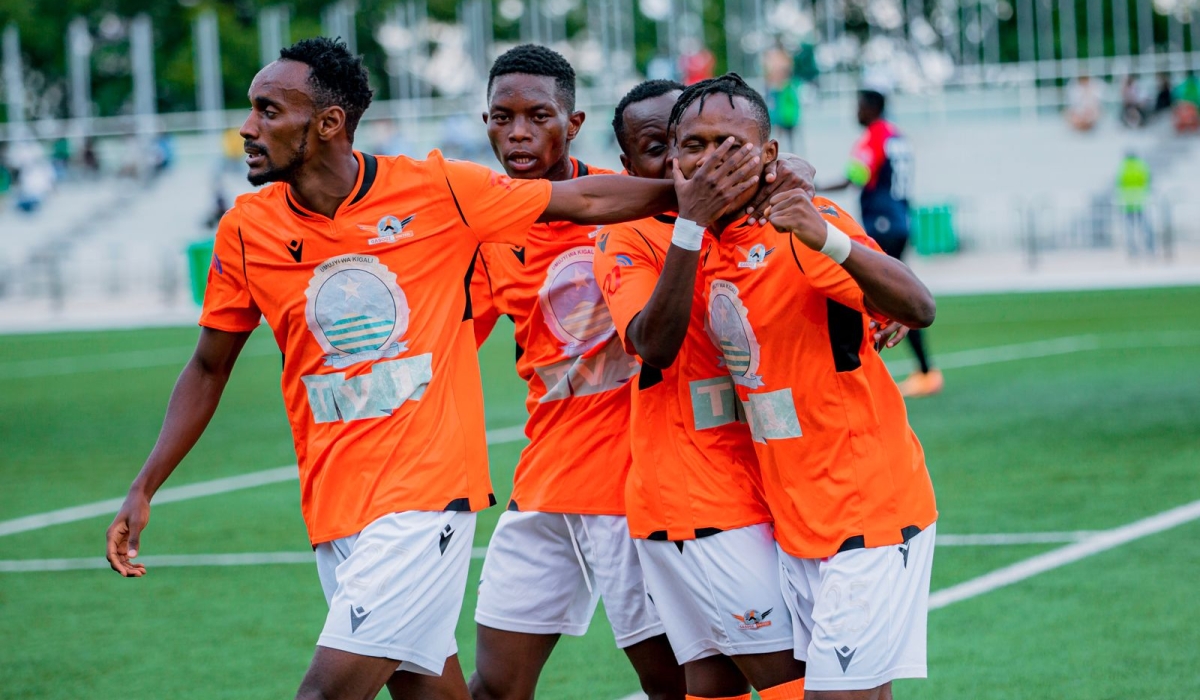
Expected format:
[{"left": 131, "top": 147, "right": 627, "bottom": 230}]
[{"left": 0, "top": 425, "right": 524, "bottom": 537}]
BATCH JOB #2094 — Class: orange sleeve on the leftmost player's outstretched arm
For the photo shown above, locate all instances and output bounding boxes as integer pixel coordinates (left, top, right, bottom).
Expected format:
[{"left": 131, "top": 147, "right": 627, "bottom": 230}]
[{"left": 444, "top": 161, "right": 552, "bottom": 245}]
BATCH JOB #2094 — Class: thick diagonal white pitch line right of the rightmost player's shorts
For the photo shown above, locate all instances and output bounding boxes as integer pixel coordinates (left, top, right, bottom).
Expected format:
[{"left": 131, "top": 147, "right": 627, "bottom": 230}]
[{"left": 929, "top": 501, "right": 1200, "bottom": 610}]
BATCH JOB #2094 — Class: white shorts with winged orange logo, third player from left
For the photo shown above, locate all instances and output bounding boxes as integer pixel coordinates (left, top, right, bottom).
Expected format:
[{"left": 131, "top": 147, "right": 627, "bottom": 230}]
[{"left": 635, "top": 523, "right": 794, "bottom": 664}]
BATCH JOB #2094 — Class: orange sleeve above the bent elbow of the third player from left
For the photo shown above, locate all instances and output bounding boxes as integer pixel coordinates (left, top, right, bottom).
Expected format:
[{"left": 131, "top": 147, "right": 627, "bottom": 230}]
[{"left": 592, "top": 223, "right": 662, "bottom": 355}]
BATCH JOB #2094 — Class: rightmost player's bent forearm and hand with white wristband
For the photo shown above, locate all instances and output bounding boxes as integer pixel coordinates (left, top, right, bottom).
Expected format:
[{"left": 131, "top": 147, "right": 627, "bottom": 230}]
[{"left": 770, "top": 190, "right": 936, "bottom": 328}]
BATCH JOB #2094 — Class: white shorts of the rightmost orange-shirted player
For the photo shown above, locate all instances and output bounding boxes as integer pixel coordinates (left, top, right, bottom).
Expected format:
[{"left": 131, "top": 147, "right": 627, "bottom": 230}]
[{"left": 780, "top": 523, "right": 937, "bottom": 690}]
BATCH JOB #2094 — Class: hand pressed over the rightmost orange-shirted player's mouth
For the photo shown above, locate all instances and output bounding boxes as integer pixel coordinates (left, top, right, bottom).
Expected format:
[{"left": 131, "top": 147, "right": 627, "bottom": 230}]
[{"left": 672, "top": 137, "right": 758, "bottom": 226}]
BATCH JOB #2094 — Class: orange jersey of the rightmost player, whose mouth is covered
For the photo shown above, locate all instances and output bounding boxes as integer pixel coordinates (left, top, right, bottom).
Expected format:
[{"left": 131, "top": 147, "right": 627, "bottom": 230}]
[{"left": 704, "top": 197, "right": 937, "bottom": 558}]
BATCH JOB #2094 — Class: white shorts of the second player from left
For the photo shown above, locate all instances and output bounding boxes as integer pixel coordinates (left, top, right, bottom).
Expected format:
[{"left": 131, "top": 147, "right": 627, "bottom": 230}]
[{"left": 475, "top": 510, "right": 662, "bottom": 648}]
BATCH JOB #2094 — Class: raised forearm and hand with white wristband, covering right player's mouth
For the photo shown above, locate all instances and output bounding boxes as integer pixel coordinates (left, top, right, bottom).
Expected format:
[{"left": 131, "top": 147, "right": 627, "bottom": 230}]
[{"left": 626, "top": 138, "right": 760, "bottom": 370}]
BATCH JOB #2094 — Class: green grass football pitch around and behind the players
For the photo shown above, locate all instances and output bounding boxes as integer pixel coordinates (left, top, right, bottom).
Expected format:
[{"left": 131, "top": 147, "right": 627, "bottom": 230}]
[{"left": 0, "top": 288, "right": 1200, "bottom": 700}]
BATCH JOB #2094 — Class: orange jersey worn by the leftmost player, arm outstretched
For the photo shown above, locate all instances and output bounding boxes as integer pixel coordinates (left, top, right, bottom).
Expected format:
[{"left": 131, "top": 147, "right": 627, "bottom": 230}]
[{"left": 200, "top": 151, "right": 551, "bottom": 544}]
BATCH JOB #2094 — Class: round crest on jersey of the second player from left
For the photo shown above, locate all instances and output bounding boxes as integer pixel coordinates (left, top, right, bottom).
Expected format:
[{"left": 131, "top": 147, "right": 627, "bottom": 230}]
[{"left": 538, "top": 246, "right": 614, "bottom": 358}]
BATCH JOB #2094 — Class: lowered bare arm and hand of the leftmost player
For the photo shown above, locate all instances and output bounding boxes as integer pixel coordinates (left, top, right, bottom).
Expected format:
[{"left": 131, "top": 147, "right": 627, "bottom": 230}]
[{"left": 107, "top": 328, "right": 250, "bottom": 576}]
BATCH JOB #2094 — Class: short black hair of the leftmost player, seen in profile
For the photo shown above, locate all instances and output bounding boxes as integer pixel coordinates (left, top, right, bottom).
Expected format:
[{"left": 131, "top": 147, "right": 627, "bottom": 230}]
[{"left": 280, "top": 36, "right": 373, "bottom": 143}]
